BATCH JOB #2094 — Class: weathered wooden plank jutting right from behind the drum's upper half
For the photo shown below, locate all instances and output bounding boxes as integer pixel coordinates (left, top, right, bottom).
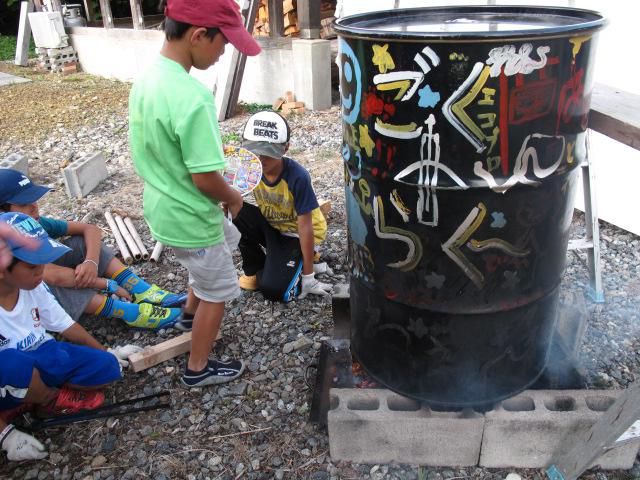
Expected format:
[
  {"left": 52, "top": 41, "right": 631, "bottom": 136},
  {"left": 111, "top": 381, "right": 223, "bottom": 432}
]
[{"left": 589, "top": 84, "right": 640, "bottom": 150}]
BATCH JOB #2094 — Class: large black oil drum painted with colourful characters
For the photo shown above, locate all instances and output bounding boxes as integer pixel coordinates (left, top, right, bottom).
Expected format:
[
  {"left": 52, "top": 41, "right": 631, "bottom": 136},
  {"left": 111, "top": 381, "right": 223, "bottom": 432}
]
[{"left": 335, "top": 6, "right": 605, "bottom": 407}]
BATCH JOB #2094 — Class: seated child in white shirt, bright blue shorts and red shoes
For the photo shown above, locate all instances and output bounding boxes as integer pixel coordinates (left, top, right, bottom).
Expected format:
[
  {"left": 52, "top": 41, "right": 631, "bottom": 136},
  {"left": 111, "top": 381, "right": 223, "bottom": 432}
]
[{"left": 0, "top": 213, "right": 135, "bottom": 460}]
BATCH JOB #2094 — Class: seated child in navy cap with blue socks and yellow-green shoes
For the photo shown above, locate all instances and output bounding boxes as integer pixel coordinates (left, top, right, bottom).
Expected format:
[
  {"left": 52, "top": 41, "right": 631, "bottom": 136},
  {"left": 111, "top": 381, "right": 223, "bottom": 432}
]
[{"left": 0, "top": 168, "right": 186, "bottom": 329}]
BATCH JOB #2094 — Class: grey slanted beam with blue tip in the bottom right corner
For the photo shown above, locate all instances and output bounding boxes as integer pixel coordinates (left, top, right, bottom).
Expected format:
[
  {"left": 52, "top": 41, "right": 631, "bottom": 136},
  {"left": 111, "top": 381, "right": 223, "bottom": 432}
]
[{"left": 547, "top": 380, "right": 640, "bottom": 480}]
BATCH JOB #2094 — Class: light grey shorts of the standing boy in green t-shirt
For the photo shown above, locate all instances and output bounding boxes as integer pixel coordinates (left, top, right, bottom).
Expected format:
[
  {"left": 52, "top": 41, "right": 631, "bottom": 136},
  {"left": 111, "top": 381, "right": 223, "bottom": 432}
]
[{"left": 173, "top": 221, "right": 240, "bottom": 303}]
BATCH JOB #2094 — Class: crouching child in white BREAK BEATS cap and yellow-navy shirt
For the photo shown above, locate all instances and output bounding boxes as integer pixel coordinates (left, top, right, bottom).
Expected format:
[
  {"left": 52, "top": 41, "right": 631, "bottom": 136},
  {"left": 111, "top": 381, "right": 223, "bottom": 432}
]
[{"left": 233, "top": 111, "right": 332, "bottom": 302}]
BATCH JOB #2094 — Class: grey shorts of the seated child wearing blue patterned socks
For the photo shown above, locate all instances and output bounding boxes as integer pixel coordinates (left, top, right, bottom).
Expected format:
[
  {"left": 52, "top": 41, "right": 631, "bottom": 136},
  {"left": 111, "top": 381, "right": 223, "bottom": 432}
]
[{"left": 47, "top": 235, "right": 114, "bottom": 321}]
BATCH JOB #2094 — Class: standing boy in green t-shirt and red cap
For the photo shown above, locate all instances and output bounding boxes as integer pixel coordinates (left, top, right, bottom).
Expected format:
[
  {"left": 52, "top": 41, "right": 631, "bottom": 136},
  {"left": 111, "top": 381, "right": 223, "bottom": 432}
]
[{"left": 129, "top": 0, "right": 260, "bottom": 387}]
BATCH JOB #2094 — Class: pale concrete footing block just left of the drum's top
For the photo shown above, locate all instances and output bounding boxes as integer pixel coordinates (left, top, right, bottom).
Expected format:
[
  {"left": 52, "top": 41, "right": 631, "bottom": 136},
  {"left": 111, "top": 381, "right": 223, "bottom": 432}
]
[{"left": 291, "top": 39, "right": 331, "bottom": 110}]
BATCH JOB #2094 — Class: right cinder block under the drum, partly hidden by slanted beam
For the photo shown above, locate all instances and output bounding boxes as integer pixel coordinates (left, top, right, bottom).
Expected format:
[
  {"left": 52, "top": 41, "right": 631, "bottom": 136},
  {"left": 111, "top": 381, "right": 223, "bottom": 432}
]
[{"left": 480, "top": 390, "right": 640, "bottom": 470}]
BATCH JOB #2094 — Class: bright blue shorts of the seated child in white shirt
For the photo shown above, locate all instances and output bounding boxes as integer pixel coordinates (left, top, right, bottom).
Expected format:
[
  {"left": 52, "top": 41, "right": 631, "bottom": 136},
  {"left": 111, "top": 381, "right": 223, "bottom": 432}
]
[{"left": 0, "top": 340, "right": 122, "bottom": 410}]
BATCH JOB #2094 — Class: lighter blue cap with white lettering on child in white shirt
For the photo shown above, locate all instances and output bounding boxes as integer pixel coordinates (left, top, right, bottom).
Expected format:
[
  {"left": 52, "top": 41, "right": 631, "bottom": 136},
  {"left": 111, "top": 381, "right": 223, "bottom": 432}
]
[{"left": 0, "top": 212, "right": 71, "bottom": 265}]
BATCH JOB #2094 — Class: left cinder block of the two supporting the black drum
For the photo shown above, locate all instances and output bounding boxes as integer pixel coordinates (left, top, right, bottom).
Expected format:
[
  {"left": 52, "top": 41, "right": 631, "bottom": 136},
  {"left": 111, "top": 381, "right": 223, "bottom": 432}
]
[{"left": 328, "top": 389, "right": 484, "bottom": 467}]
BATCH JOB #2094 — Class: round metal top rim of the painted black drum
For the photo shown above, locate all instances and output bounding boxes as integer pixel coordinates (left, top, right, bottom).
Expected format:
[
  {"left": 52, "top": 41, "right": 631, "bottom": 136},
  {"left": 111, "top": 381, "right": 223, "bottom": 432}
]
[{"left": 333, "top": 5, "right": 608, "bottom": 41}]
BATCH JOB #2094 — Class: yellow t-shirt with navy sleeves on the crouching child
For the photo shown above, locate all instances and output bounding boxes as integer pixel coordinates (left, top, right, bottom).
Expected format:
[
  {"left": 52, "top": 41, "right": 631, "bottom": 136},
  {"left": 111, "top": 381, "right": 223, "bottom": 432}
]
[{"left": 253, "top": 157, "right": 327, "bottom": 245}]
